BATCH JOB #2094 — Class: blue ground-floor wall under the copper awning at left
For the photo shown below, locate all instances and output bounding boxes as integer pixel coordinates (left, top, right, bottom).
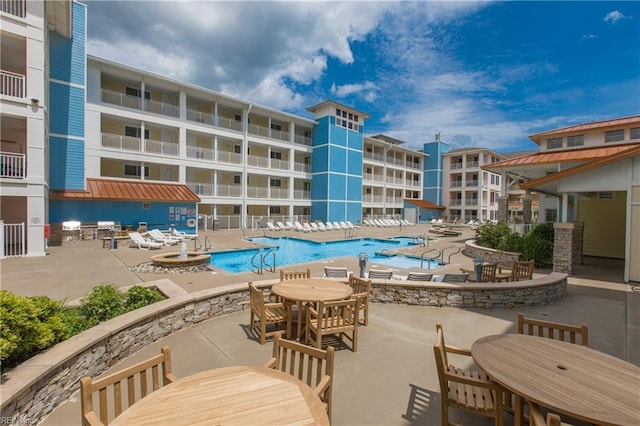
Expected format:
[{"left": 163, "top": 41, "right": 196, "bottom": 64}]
[{"left": 49, "top": 200, "right": 196, "bottom": 229}]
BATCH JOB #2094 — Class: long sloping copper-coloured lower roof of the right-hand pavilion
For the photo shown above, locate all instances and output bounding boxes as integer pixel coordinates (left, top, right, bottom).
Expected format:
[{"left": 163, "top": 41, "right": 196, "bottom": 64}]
[{"left": 482, "top": 143, "right": 638, "bottom": 169}]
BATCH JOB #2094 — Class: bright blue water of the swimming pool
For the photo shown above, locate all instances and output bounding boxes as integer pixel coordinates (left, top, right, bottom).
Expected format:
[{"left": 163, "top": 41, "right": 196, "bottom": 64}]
[{"left": 209, "top": 237, "right": 441, "bottom": 273}]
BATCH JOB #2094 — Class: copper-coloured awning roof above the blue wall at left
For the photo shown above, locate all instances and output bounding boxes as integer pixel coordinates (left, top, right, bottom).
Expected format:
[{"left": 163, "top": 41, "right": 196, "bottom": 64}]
[{"left": 49, "top": 178, "right": 200, "bottom": 203}]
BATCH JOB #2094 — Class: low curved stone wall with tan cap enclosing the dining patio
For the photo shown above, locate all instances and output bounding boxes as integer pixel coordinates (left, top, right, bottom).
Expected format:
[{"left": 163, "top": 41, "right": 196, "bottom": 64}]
[{"left": 0, "top": 273, "right": 567, "bottom": 424}]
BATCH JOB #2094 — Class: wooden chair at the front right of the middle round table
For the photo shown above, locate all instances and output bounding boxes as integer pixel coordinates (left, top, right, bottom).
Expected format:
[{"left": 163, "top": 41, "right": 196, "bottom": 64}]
[{"left": 305, "top": 298, "right": 360, "bottom": 352}]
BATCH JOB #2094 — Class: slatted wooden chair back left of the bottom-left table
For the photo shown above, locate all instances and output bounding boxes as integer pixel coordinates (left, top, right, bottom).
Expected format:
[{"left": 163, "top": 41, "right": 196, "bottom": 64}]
[{"left": 80, "top": 346, "right": 176, "bottom": 426}]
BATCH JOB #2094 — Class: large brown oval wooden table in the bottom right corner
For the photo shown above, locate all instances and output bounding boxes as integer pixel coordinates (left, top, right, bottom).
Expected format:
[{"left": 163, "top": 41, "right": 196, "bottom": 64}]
[{"left": 471, "top": 334, "right": 640, "bottom": 426}]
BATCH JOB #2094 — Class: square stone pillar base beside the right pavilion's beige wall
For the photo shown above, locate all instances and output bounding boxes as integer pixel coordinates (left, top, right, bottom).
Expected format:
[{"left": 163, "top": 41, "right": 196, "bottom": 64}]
[{"left": 553, "top": 222, "right": 584, "bottom": 275}]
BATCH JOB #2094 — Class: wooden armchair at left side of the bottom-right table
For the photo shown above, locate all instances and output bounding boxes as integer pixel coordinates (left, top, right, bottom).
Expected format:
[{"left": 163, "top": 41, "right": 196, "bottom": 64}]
[{"left": 433, "top": 324, "right": 503, "bottom": 426}]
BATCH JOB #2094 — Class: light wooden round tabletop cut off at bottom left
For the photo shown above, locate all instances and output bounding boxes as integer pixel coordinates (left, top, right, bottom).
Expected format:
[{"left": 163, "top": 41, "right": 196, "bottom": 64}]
[{"left": 111, "top": 366, "right": 329, "bottom": 426}]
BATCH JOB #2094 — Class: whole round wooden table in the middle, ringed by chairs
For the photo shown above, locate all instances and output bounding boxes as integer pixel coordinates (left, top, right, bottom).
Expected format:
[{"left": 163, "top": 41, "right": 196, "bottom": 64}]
[{"left": 271, "top": 278, "right": 353, "bottom": 340}]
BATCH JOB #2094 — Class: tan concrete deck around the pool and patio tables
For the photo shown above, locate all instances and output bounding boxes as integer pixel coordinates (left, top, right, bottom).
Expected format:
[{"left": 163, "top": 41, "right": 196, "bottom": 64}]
[{"left": 0, "top": 225, "right": 640, "bottom": 425}]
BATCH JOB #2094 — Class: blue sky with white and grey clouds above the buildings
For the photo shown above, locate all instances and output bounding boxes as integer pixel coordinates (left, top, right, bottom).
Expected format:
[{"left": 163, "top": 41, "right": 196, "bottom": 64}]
[{"left": 84, "top": 0, "right": 640, "bottom": 153}]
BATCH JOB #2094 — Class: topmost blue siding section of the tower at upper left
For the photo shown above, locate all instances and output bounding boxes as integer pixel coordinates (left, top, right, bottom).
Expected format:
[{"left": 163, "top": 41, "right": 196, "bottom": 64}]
[{"left": 49, "top": 2, "right": 87, "bottom": 86}]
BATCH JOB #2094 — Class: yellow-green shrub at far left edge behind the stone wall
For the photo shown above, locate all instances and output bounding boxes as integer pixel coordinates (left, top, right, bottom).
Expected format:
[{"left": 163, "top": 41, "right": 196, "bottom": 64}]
[{"left": 0, "top": 290, "right": 69, "bottom": 370}]
